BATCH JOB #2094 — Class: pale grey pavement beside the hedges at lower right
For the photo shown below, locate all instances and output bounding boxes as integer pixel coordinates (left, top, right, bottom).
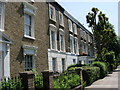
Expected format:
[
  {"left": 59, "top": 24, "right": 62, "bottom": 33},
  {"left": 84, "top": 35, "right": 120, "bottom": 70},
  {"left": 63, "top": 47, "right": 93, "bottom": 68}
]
[{"left": 85, "top": 66, "right": 120, "bottom": 90}]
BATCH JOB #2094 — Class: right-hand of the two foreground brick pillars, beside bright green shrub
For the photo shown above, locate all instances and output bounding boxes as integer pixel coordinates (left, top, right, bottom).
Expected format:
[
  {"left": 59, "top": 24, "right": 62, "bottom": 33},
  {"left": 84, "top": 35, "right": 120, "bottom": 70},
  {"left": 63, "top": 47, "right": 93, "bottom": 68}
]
[{"left": 42, "top": 70, "right": 53, "bottom": 90}]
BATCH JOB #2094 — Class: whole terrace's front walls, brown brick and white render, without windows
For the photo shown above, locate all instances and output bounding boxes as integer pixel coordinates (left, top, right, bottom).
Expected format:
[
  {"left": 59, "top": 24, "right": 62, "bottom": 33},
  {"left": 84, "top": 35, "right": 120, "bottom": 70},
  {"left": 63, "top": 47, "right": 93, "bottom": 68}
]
[{"left": 0, "top": 2, "right": 93, "bottom": 77}]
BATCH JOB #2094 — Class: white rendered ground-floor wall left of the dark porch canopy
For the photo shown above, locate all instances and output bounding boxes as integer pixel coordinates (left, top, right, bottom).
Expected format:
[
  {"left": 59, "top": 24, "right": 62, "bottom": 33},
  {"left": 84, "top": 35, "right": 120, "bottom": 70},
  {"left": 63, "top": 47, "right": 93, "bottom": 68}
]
[{"left": 48, "top": 51, "right": 78, "bottom": 72}]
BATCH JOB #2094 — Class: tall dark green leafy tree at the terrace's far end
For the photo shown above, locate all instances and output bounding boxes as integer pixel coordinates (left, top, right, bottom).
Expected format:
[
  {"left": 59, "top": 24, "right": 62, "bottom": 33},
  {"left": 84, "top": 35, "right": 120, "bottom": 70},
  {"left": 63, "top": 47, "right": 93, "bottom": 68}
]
[{"left": 86, "top": 8, "right": 120, "bottom": 61}]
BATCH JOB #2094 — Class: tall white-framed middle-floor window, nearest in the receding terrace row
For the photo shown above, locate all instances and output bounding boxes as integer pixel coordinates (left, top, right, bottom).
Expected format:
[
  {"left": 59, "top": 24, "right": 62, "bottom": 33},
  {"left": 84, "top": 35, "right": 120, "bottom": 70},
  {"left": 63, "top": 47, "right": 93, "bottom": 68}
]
[{"left": 49, "top": 25, "right": 57, "bottom": 50}]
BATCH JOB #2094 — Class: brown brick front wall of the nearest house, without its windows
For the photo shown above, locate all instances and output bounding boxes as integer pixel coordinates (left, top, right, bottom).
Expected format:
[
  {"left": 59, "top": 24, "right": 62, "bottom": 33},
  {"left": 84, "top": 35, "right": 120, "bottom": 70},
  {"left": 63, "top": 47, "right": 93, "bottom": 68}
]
[{"left": 4, "top": 2, "right": 48, "bottom": 76}]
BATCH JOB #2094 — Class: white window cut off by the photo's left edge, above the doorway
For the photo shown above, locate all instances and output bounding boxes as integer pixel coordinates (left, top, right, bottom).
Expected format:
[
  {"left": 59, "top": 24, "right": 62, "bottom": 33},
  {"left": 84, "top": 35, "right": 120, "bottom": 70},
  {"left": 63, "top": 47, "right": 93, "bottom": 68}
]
[{"left": 0, "top": 2, "right": 5, "bottom": 31}]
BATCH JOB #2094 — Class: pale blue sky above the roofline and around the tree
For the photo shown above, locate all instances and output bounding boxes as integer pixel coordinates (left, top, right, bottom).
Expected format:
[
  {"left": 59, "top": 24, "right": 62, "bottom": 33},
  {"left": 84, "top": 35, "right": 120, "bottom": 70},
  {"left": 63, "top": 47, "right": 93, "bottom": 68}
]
[{"left": 57, "top": 0, "right": 118, "bottom": 35}]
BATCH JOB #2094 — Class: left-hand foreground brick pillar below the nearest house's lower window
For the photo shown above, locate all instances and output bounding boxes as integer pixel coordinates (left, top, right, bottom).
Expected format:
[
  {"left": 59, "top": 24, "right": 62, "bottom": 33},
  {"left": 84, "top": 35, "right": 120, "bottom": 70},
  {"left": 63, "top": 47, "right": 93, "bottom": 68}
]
[{"left": 20, "top": 71, "right": 35, "bottom": 90}]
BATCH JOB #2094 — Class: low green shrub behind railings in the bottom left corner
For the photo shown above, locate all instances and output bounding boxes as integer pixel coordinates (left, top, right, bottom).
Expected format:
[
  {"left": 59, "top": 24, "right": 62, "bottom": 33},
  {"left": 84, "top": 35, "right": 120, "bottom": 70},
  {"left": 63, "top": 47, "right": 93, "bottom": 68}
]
[{"left": 0, "top": 77, "right": 23, "bottom": 90}]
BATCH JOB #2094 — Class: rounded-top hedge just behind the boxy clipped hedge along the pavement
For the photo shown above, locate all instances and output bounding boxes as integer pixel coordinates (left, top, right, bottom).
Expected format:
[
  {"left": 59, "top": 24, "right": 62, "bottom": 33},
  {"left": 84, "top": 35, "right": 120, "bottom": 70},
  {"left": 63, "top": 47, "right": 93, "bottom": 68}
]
[{"left": 92, "top": 61, "right": 107, "bottom": 78}]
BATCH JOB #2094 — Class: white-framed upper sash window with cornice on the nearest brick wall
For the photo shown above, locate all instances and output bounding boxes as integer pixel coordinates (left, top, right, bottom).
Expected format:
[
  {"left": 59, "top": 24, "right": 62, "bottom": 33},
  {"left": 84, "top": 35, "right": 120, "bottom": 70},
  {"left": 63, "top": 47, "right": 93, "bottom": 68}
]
[{"left": 24, "top": 2, "right": 36, "bottom": 39}]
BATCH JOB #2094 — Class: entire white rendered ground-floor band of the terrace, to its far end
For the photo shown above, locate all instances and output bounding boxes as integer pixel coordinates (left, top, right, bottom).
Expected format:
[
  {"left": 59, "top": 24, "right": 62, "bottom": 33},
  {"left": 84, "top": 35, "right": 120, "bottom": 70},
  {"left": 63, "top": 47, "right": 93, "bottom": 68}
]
[{"left": 48, "top": 50, "right": 94, "bottom": 72}]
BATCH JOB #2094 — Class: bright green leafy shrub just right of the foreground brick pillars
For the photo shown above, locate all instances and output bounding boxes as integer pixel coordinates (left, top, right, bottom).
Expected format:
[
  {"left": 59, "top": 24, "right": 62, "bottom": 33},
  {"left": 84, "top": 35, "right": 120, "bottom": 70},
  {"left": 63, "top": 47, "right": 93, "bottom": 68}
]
[{"left": 54, "top": 72, "right": 80, "bottom": 89}]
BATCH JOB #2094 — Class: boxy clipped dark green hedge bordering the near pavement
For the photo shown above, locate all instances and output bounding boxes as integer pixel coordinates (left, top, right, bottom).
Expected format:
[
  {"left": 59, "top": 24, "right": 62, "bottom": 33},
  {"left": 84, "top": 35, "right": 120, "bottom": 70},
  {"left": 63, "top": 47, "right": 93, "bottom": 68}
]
[{"left": 82, "top": 66, "right": 100, "bottom": 85}]
